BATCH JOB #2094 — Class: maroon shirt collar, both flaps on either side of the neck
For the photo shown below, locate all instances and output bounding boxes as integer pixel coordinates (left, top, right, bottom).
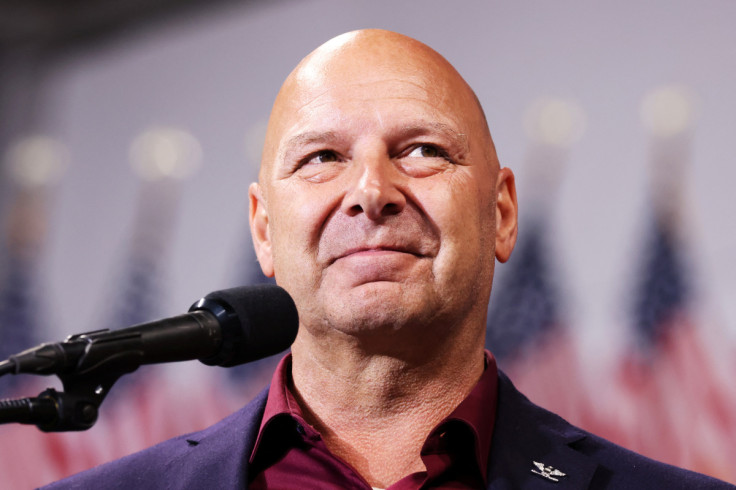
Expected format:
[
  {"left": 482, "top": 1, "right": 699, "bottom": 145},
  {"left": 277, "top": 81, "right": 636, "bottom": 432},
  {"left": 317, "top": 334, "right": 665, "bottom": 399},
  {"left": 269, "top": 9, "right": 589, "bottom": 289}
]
[{"left": 250, "top": 350, "right": 498, "bottom": 478}]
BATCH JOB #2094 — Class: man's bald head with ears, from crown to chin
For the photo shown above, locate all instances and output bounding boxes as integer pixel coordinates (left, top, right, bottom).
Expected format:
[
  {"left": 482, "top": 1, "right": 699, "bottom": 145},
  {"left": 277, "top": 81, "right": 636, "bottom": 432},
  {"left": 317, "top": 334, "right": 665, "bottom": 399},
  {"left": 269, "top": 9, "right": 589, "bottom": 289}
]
[{"left": 250, "top": 30, "right": 516, "bottom": 354}]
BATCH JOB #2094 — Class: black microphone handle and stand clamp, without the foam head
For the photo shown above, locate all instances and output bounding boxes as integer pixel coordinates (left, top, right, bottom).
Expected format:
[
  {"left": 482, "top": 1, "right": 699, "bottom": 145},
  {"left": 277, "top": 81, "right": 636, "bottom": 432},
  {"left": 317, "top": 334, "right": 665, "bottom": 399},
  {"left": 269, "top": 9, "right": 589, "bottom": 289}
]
[{"left": 0, "top": 310, "right": 220, "bottom": 432}]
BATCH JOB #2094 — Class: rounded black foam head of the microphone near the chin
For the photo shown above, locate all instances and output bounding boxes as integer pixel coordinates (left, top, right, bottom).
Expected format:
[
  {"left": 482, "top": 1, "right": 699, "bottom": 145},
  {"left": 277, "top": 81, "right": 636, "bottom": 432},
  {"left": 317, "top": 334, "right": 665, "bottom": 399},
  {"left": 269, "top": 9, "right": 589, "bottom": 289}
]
[{"left": 189, "top": 284, "right": 299, "bottom": 367}]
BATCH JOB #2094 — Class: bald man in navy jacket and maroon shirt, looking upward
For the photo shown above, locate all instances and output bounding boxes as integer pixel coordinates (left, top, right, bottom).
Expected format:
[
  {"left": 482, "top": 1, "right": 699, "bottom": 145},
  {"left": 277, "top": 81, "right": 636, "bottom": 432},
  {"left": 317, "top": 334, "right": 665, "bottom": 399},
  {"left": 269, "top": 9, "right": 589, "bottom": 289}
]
[{"left": 49, "top": 30, "right": 730, "bottom": 490}]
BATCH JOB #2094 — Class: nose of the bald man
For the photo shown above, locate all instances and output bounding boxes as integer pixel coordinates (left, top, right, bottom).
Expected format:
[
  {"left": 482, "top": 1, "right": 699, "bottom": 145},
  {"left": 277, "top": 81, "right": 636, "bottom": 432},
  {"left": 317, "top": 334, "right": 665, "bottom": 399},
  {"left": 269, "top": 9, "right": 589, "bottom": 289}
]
[{"left": 342, "top": 158, "right": 406, "bottom": 221}]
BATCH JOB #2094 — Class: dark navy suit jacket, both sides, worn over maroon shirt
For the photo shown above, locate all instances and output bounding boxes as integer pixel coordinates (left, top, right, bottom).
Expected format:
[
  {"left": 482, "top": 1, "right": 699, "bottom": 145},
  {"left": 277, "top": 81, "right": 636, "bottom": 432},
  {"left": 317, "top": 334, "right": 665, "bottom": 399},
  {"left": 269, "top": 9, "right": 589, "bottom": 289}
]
[{"left": 43, "top": 372, "right": 736, "bottom": 490}]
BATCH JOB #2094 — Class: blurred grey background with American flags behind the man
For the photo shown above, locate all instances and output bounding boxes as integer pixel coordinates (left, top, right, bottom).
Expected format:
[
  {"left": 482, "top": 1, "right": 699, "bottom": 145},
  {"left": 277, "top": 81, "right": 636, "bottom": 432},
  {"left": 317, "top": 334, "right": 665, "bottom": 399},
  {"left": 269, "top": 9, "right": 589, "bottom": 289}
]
[{"left": 0, "top": 0, "right": 736, "bottom": 488}]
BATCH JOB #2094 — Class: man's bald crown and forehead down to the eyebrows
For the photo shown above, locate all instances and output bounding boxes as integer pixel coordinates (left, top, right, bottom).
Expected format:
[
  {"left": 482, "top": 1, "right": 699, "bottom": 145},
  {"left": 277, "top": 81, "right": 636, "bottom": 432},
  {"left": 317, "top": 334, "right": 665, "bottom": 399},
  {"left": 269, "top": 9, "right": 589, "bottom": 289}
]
[{"left": 261, "top": 34, "right": 492, "bottom": 176}]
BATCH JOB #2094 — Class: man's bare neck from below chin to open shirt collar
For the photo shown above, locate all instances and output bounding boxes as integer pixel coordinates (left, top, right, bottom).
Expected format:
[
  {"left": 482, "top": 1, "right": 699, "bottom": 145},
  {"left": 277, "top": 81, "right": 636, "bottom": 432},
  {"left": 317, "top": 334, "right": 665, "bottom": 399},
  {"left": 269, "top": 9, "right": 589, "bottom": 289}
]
[{"left": 292, "top": 329, "right": 484, "bottom": 488}]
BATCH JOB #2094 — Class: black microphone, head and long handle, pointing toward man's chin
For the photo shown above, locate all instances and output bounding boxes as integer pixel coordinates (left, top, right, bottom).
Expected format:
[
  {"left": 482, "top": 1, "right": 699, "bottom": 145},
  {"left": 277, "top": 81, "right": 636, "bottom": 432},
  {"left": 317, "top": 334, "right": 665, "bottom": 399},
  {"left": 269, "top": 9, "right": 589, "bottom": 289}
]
[{"left": 0, "top": 285, "right": 299, "bottom": 376}]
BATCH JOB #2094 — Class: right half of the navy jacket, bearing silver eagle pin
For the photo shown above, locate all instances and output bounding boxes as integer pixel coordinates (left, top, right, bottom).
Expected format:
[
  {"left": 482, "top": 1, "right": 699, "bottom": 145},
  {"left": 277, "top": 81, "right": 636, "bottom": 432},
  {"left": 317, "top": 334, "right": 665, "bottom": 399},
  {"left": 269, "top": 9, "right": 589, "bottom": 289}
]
[{"left": 488, "top": 371, "right": 736, "bottom": 489}]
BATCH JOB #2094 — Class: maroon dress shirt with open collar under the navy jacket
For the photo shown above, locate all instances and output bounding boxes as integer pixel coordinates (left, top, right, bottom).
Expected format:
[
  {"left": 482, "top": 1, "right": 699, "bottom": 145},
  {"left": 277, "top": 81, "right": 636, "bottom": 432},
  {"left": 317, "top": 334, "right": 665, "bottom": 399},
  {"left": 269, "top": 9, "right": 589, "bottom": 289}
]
[{"left": 249, "top": 351, "right": 498, "bottom": 490}]
